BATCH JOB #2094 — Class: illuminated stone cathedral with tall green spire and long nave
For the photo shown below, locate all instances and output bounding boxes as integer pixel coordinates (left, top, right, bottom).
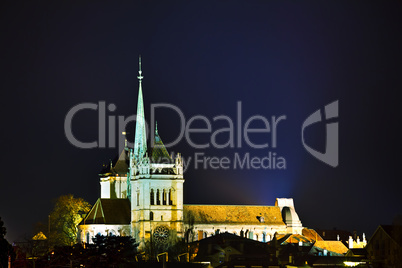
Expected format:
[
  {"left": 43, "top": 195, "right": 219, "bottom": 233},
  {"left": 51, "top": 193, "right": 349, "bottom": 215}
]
[{"left": 78, "top": 59, "right": 303, "bottom": 247}]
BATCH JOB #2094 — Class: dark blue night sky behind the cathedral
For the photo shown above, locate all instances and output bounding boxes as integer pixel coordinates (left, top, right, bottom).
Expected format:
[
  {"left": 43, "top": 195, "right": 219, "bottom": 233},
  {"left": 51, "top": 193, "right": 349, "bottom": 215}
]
[{"left": 0, "top": 1, "right": 402, "bottom": 242}]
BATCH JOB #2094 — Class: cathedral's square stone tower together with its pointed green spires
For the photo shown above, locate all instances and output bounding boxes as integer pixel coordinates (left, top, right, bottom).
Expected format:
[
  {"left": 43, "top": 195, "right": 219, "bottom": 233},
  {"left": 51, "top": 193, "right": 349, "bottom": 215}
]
[{"left": 127, "top": 58, "right": 184, "bottom": 247}]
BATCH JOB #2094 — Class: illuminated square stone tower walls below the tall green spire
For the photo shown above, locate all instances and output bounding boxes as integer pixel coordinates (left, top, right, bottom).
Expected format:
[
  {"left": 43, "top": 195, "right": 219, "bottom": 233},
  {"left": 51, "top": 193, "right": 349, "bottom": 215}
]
[{"left": 130, "top": 155, "right": 184, "bottom": 247}]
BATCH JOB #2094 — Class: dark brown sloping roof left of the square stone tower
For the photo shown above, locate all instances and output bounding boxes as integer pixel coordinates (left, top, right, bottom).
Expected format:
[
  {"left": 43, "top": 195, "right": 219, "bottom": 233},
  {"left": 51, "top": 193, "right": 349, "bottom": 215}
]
[{"left": 80, "top": 198, "right": 131, "bottom": 225}]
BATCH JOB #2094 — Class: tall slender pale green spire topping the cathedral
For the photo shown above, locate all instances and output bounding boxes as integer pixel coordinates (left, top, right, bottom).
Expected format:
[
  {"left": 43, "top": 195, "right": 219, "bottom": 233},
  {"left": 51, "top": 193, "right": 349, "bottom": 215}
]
[{"left": 134, "top": 56, "right": 147, "bottom": 161}]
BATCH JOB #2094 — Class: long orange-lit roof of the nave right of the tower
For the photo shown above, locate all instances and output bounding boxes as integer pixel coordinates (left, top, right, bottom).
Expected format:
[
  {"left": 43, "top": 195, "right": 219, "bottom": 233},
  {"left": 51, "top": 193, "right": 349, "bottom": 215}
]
[{"left": 183, "top": 205, "right": 285, "bottom": 225}]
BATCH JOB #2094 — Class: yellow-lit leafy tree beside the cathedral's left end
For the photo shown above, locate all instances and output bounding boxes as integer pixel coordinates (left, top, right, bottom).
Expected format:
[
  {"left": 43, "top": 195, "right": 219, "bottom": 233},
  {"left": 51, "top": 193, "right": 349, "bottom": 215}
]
[{"left": 49, "top": 194, "right": 91, "bottom": 246}]
